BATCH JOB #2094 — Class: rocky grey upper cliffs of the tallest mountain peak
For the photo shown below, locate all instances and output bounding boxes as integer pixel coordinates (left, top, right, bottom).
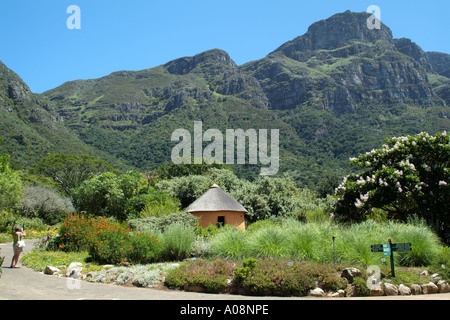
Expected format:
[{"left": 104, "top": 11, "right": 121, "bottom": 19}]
[{"left": 242, "top": 12, "right": 444, "bottom": 115}]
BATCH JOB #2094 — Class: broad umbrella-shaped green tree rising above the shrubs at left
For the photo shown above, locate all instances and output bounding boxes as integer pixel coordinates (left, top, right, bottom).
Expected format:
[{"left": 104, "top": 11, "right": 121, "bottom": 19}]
[{"left": 30, "top": 154, "right": 114, "bottom": 197}]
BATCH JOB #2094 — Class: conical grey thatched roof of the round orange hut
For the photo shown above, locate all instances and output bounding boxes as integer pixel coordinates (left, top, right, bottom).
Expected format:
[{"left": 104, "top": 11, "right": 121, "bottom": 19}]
[{"left": 188, "top": 184, "right": 247, "bottom": 212}]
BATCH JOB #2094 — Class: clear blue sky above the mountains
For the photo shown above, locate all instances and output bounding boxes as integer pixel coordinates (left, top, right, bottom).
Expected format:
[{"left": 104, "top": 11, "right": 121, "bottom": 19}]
[{"left": 0, "top": 0, "right": 450, "bottom": 93}]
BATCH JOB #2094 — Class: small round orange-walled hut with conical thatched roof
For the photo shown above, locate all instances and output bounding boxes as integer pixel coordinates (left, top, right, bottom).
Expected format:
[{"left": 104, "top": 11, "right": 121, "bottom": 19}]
[{"left": 188, "top": 184, "right": 247, "bottom": 230}]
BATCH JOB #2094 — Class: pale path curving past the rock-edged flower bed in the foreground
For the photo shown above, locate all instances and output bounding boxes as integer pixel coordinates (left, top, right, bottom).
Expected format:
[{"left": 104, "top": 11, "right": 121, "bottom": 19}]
[{"left": 0, "top": 240, "right": 450, "bottom": 301}]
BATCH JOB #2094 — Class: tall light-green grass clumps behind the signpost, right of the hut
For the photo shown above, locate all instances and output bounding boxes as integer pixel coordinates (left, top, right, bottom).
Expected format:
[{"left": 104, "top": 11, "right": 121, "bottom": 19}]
[{"left": 209, "top": 220, "right": 441, "bottom": 267}]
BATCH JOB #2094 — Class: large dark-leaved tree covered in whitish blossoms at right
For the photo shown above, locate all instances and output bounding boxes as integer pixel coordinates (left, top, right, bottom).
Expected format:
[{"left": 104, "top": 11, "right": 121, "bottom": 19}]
[{"left": 335, "top": 131, "right": 450, "bottom": 240}]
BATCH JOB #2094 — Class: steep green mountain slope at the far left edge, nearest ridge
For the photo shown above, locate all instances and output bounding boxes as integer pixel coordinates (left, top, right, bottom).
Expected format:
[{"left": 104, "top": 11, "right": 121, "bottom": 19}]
[{"left": 0, "top": 62, "right": 123, "bottom": 168}]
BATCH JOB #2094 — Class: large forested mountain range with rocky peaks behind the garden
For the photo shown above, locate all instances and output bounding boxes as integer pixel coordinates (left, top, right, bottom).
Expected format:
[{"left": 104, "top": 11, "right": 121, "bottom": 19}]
[{"left": 1, "top": 11, "right": 450, "bottom": 189}]
